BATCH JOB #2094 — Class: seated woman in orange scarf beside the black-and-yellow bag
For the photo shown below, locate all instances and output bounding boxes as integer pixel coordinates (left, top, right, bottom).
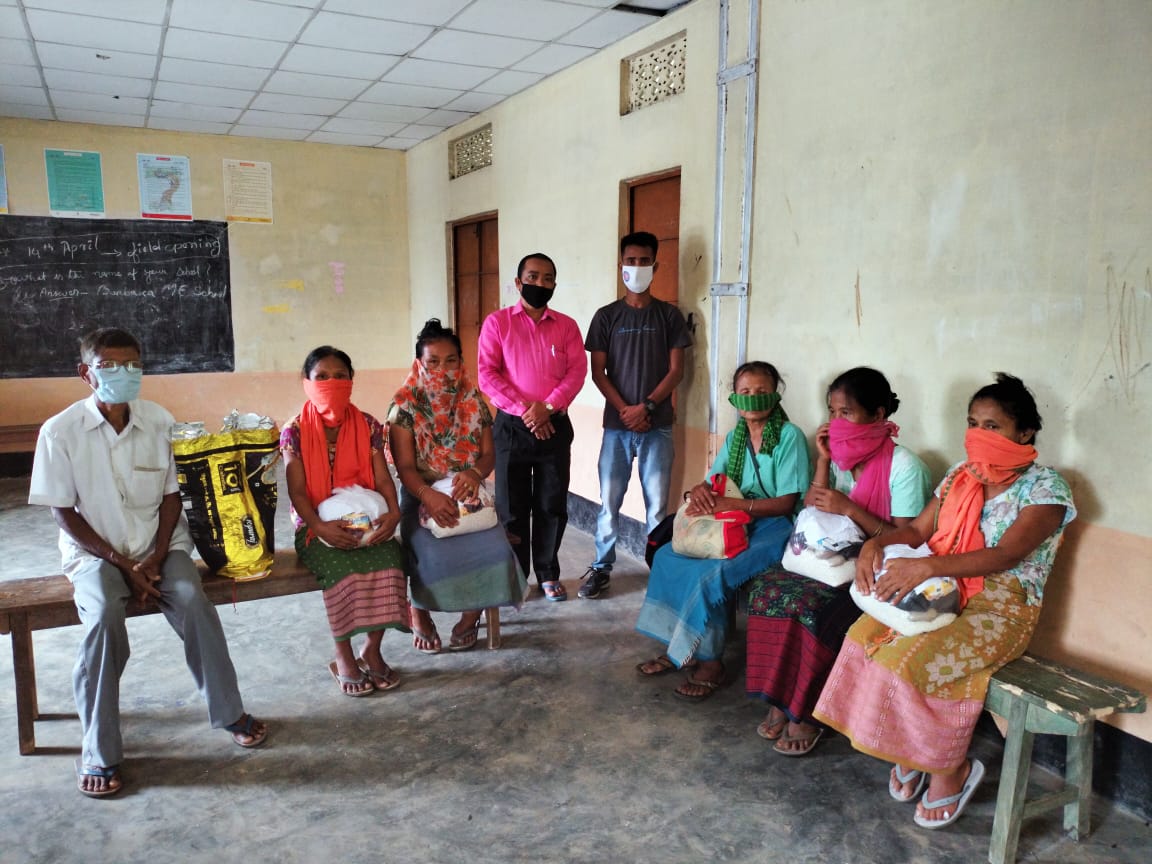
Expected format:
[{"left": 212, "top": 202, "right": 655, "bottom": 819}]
[{"left": 280, "top": 346, "right": 409, "bottom": 696}]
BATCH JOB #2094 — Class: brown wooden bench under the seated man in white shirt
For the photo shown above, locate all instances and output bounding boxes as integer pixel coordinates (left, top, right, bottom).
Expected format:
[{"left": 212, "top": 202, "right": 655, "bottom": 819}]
[{"left": 0, "top": 550, "right": 500, "bottom": 756}]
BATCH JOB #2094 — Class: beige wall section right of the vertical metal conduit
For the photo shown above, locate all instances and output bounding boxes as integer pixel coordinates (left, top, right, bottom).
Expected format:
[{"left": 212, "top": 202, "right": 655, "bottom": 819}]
[{"left": 751, "top": 0, "right": 1152, "bottom": 738}]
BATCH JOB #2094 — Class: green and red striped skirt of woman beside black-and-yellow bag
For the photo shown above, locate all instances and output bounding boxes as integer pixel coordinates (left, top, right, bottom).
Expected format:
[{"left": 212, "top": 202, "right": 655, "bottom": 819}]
[{"left": 296, "top": 528, "right": 409, "bottom": 642}]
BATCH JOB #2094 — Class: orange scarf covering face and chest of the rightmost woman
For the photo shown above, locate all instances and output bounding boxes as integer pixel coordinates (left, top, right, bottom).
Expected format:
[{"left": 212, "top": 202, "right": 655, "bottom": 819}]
[{"left": 929, "top": 429, "right": 1037, "bottom": 605}]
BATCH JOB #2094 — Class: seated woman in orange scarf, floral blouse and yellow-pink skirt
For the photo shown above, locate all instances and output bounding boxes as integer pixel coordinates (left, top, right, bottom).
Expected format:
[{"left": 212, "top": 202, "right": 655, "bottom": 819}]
[{"left": 814, "top": 372, "right": 1076, "bottom": 828}]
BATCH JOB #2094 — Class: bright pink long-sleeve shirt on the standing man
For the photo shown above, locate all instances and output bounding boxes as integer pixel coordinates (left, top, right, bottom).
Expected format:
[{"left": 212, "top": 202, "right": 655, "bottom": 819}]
[{"left": 477, "top": 303, "right": 588, "bottom": 417}]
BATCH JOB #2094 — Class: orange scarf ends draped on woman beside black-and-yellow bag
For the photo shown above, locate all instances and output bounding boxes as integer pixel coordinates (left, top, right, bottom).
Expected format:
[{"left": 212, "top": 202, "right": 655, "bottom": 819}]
[{"left": 300, "top": 381, "right": 376, "bottom": 507}]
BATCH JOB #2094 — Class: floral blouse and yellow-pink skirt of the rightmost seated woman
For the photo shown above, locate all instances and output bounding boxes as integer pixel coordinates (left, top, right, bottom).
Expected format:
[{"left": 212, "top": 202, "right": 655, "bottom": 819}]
[{"left": 814, "top": 463, "right": 1076, "bottom": 773}]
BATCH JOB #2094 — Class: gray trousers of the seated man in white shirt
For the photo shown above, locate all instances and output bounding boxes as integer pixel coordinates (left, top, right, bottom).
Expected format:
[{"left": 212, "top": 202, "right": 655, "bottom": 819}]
[{"left": 71, "top": 552, "right": 244, "bottom": 767}]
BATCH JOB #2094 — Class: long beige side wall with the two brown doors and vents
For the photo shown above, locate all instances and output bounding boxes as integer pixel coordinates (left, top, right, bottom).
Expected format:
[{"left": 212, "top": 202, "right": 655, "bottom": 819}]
[{"left": 408, "top": 0, "right": 1152, "bottom": 740}]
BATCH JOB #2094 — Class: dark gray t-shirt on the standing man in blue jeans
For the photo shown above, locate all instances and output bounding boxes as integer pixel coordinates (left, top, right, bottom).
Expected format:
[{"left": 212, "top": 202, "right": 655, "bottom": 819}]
[{"left": 584, "top": 297, "right": 692, "bottom": 429}]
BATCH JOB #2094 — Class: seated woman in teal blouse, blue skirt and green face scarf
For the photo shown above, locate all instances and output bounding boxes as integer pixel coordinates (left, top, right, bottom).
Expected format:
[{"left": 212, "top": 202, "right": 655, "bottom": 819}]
[{"left": 636, "top": 361, "right": 811, "bottom": 702}]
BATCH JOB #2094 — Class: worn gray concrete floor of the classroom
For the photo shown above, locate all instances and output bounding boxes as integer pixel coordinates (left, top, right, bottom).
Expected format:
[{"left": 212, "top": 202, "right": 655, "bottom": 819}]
[{"left": 0, "top": 478, "right": 1152, "bottom": 864}]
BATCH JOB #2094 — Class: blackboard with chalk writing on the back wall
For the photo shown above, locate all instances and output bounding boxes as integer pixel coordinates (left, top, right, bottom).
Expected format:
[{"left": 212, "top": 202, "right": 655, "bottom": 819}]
[{"left": 0, "top": 215, "right": 235, "bottom": 378}]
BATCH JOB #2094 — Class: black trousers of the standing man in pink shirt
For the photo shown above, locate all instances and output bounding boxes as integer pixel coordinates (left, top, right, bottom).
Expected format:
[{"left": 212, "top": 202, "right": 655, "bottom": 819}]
[{"left": 492, "top": 411, "right": 574, "bottom": 583}]
